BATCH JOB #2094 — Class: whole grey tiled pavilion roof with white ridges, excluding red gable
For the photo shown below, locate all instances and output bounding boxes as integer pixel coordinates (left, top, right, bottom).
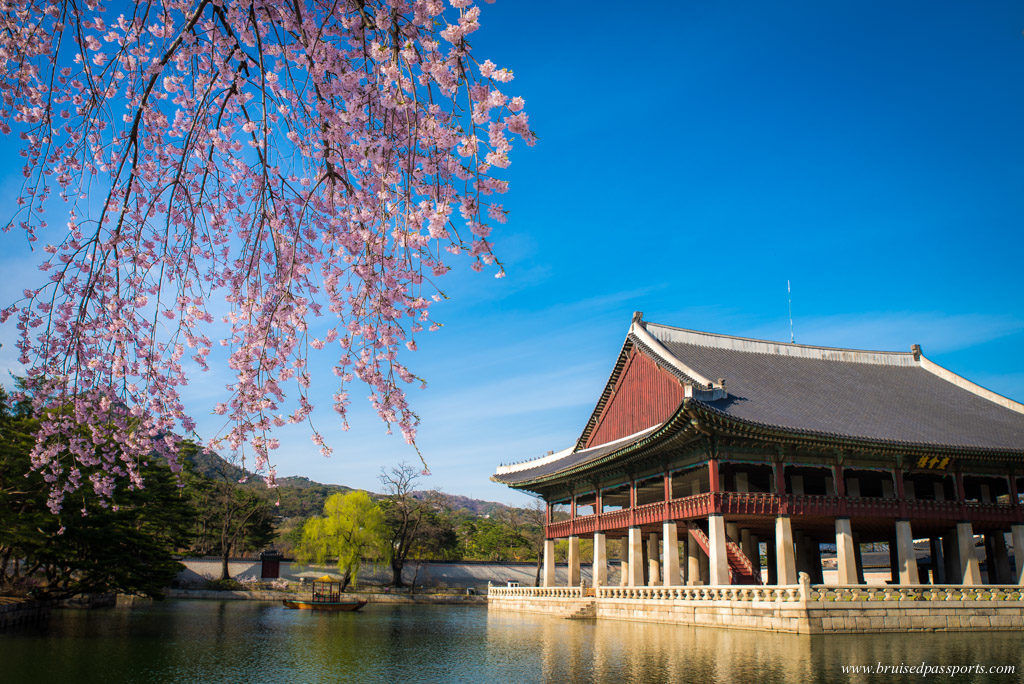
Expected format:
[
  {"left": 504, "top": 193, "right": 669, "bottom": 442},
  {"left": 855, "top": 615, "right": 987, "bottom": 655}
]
[{"left": 493, "top": 314, "right": 1024, "bottom": 485}]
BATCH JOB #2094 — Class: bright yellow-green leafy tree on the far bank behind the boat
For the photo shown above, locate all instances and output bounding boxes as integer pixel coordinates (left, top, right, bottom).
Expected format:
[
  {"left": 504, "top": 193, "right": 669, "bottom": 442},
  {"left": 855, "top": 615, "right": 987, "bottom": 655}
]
[{"left": 297, "top": 491, "right": 387, "bottom": 591}]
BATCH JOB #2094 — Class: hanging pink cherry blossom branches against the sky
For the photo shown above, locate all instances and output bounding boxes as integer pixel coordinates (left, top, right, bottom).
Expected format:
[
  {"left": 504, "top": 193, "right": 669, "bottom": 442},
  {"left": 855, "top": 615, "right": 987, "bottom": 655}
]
[{"left": 0, "top": 0, "right": 535, "bottom": 511}]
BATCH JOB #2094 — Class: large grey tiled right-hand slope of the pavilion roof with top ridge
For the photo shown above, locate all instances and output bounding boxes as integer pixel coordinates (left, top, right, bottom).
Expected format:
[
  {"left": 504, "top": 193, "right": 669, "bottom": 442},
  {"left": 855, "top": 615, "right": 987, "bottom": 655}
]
[{"left": 647, "top": 324, "right": 1024, "bottom": 452}]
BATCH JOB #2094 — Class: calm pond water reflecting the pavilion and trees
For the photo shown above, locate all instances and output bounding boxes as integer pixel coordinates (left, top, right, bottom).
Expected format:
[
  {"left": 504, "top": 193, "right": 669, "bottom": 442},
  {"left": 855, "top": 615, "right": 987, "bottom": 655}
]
[{"left": 0, "top": 601, "right": 1024, "bottom": 684}]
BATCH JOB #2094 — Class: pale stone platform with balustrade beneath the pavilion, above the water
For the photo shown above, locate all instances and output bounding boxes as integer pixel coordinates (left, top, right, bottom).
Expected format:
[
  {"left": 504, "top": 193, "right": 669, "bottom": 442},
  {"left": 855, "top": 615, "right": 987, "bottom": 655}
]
[{"left": 487, "top": 582, "right": 1024, "bottom": 634}]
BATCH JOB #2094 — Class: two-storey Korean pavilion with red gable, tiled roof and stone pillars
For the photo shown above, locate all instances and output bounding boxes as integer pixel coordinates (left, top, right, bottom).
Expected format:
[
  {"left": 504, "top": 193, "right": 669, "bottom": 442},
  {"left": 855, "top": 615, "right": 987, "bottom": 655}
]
[{"left": 493, "top": 312, "right": 1024, "bottom": 587}]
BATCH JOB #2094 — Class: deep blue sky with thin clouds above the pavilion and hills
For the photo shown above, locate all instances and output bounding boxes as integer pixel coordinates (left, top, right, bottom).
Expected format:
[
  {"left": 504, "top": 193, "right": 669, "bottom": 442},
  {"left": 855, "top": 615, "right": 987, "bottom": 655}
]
[{"left": 0, "top": 0, "right": 1024, "bottom": 503}]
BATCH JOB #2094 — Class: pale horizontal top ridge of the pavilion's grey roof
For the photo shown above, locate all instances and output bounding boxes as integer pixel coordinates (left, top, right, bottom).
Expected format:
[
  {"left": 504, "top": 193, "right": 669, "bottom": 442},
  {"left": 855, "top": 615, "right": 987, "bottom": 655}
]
[{"left": 640, "top": 320, "right": 919, "bottom": 367}]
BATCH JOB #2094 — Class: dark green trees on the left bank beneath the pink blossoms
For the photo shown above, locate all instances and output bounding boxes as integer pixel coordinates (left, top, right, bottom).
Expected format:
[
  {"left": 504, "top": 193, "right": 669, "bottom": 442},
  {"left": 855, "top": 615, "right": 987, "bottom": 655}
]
[{"left": 0, "top": 387, "right": 194, "bottom": 599}]
